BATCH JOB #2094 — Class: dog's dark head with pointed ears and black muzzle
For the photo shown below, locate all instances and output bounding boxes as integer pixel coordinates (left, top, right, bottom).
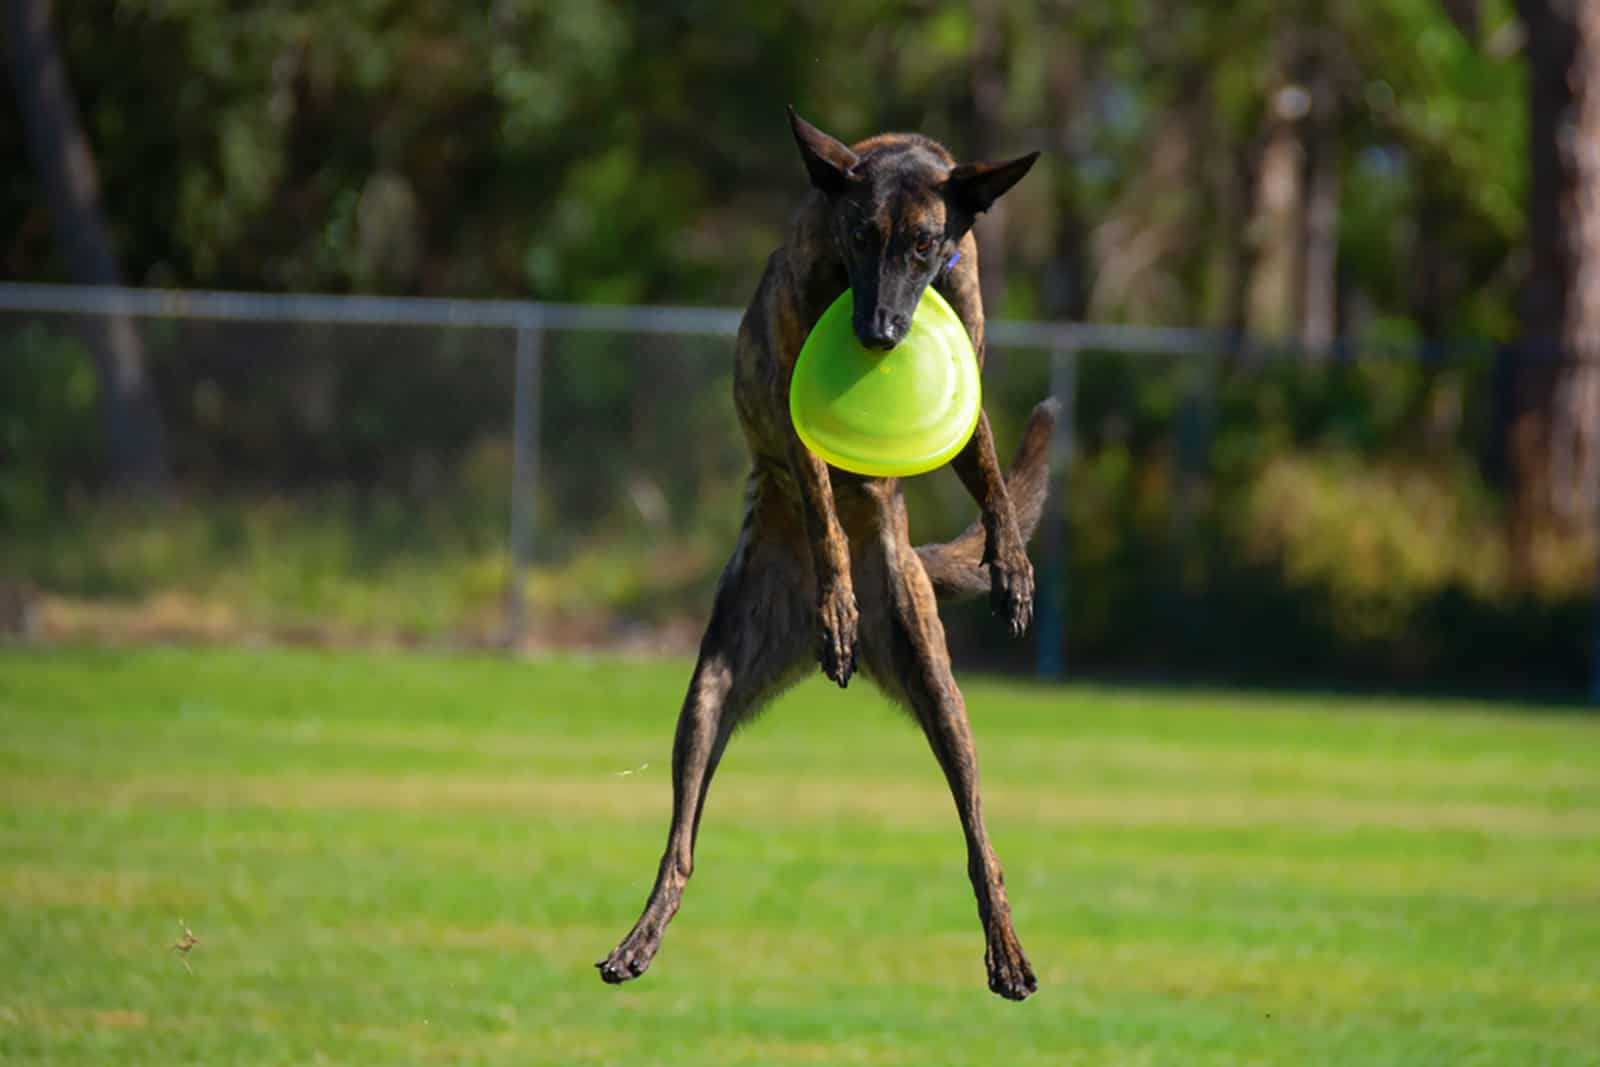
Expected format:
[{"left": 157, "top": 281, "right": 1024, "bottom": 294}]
[{"left": 789, "top": 109, "right": 1038, "bottom": 349}]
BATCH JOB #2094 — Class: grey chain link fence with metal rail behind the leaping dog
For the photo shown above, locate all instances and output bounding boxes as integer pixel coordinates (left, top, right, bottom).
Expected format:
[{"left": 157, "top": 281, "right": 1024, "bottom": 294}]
[{"left": 0, "top": 285, "right": 1590, "bottom": 697}]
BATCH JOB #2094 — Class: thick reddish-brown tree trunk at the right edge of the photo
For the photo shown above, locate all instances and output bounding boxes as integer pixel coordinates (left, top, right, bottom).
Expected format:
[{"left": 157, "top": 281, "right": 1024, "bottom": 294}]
[{"left": 1507, "top": 0, "right": 1600, "bottom": 582}]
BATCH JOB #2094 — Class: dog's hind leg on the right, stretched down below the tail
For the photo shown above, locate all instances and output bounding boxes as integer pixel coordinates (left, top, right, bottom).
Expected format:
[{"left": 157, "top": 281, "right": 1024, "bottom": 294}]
[{"left": 856, "top": 517, "right": 1038, "bottom": 1000}]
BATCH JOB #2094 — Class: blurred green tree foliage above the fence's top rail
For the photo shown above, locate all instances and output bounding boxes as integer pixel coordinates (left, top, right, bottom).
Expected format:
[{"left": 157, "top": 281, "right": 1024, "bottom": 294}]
[{"left": 0, "top": 0, "right": 1526, "bottom": 333}]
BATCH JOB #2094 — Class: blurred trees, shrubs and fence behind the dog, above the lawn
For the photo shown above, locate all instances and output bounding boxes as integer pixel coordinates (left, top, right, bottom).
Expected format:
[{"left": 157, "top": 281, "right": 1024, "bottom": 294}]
[{"left": 0, "top": 0, "right": 1600, "bottom": 696}]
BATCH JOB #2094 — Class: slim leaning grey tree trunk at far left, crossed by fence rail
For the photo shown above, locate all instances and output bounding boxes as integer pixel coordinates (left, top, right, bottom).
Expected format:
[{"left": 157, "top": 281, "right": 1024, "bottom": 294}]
[{"left": 6, "top": 0, "right": 166, "bottom": 488}]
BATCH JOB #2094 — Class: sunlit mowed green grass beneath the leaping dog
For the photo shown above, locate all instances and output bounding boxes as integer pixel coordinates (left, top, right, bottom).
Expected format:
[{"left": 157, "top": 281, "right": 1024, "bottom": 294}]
[{"left": 0, "top": 649, "right": 1600, "bottom": 1065}]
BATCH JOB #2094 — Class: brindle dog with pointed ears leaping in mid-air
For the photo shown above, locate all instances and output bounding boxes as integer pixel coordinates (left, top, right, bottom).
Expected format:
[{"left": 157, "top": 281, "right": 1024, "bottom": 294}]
[{"left": 597, "top": 110, "right": 1054, "bottom": 1000}]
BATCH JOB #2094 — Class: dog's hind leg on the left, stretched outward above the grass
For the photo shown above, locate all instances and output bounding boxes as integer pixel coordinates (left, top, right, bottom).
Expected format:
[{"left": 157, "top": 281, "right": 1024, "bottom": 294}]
[{"left": 595, "top": 525, "right": 813, "bottom": 984}]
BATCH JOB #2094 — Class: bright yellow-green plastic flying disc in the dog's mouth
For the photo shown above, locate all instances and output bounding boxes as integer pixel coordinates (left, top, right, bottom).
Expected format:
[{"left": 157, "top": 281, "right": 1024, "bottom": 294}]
[{"left": 789, "top": 288, "right": 982, "bottom": 478}]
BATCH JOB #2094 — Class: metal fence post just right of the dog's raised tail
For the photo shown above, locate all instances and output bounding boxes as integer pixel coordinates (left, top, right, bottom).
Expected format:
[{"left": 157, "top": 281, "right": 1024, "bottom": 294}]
[{"left": 1034, "top": 336, "right": 1078, "bottom": 678}]
